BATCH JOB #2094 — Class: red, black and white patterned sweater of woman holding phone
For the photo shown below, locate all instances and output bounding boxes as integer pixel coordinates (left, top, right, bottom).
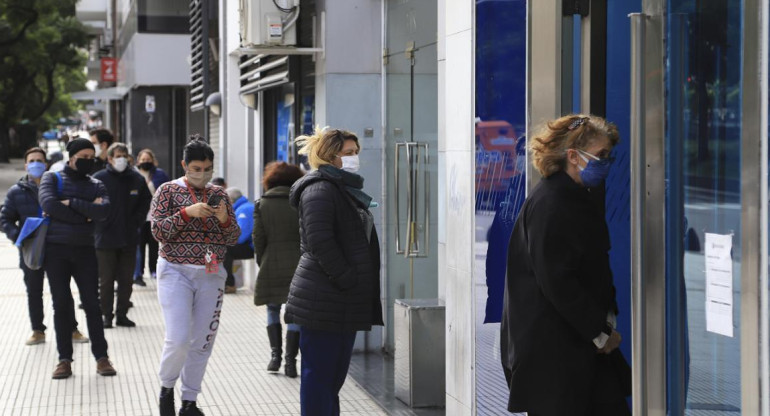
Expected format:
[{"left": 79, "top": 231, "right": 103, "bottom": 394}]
[{"left": 150, "top": 178, "right": 241, "bottom": 266}]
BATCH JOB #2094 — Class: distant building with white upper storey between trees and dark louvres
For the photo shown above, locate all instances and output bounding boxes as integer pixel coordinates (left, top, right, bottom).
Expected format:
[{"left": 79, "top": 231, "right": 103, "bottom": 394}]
[{"left": 73, "top": 0, "right": 198, "bottom": 176}]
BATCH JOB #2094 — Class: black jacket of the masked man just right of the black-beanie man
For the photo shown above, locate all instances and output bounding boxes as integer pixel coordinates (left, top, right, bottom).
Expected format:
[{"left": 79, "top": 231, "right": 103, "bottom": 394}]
[{"left": 94, "top": 165, "right": 152, "bottom": 249}]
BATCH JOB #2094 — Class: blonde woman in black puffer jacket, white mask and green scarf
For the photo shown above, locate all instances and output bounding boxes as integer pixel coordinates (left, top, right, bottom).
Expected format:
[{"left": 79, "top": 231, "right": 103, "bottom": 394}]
[{"left": 285, "top": 129, "right": 383, "bottom": 415}]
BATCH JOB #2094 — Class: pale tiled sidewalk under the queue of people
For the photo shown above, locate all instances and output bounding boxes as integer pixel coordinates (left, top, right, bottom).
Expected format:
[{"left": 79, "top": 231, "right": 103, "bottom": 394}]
[{"left": 0, "top": 236, "right": 386, "bottom": 416}]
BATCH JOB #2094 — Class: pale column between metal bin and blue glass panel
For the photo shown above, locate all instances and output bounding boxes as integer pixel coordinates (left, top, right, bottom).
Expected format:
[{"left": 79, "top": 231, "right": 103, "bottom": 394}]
[{"left": 438, "top": 0, "right": 475, "bottom": 415}]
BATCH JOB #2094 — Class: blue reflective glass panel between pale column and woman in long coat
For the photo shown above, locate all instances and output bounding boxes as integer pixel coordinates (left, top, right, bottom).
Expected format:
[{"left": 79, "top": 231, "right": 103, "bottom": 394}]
[{"left": 474, "top": 0, "right": 527, "bottom": 415}]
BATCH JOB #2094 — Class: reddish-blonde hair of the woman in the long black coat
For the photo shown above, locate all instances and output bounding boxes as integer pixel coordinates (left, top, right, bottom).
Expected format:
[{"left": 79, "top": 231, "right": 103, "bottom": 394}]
[{"left": 529, "top": 114, "right": 620, "bottom": 178}]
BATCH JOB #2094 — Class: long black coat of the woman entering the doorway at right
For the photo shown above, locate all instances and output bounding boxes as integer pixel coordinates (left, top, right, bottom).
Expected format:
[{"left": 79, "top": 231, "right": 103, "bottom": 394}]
[{"left": 501, "top": 172, "right": 630, "bottom": 416}]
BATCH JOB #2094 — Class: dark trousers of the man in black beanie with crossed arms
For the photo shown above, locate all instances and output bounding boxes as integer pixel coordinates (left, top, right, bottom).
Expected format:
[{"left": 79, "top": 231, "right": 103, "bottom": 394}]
[{"left": 45, "top": 243, "right": 107, "bottom": 361}]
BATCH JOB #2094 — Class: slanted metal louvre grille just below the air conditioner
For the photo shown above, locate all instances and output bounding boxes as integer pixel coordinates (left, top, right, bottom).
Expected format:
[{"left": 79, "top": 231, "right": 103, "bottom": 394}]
[{"left": 239, "top": 54, "right": 291, "bottom": 95}]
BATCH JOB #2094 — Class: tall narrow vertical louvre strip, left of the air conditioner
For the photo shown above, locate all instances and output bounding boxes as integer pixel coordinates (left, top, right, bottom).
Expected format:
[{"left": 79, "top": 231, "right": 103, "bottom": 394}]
[{"left": 190, "top": 0, "right": 209, "bottom": 111}]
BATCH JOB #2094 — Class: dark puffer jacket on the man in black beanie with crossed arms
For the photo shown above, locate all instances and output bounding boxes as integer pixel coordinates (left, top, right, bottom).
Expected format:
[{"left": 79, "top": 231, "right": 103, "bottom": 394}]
[{"left": 39, "top": 166, "right": 110, "bottom": 247}]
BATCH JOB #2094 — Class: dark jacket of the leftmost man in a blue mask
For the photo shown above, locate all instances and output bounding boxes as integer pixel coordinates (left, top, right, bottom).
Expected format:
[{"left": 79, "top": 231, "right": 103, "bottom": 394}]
[{"left": 0, "top": 176, "right": 40, "bottom": 242}]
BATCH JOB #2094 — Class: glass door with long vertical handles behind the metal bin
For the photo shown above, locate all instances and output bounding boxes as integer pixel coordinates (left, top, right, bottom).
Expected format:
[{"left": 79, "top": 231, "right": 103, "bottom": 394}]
[{"left": 384, "top": 0, "right": 438, "bottom": 351}]
